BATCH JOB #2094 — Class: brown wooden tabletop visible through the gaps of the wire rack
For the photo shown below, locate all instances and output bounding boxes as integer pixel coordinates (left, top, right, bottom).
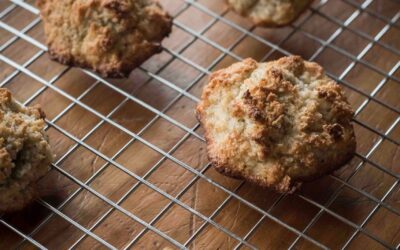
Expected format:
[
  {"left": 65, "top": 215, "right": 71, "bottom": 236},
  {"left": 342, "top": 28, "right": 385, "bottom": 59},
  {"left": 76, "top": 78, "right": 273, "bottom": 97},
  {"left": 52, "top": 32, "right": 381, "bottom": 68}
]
[{"left": 0, "top": 0, "right": 400, "bottom": 249}]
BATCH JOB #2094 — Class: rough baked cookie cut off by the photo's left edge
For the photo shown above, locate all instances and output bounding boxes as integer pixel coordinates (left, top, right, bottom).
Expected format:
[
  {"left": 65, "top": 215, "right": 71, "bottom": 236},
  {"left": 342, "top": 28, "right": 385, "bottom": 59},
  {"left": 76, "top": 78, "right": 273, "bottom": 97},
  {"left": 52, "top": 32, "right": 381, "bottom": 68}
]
[{"left": 0, "top": 88, "right": 53, "bottom": 213}]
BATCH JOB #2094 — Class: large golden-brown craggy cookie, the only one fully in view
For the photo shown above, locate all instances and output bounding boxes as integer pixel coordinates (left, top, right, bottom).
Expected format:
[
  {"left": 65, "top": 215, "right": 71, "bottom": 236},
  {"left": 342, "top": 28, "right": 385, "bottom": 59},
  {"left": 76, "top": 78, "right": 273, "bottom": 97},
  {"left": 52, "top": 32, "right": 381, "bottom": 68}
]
[{"left": 197, "top": 56, "right": 356, "bottom": 192}]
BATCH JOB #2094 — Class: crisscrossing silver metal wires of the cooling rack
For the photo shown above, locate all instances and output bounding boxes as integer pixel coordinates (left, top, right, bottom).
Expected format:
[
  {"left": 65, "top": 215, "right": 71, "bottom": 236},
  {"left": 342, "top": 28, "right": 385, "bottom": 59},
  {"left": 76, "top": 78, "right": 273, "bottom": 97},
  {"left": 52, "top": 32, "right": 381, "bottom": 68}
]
[{"left": 0, "top": 0, "right": 400, "bottom": 249}]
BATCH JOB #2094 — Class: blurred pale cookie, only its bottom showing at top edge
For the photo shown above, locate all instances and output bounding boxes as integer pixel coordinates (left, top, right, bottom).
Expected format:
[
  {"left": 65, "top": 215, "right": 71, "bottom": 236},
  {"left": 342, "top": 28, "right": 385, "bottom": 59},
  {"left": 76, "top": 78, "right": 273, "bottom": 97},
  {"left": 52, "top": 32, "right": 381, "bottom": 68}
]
[{"left": 227, "top": 0, "right": 312, "bottom": 27}]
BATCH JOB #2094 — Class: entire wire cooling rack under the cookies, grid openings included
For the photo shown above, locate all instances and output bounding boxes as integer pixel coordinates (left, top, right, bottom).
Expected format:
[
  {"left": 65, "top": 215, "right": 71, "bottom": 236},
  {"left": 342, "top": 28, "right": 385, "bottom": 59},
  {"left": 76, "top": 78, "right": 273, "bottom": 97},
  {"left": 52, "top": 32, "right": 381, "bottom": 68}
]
[{"left": 0, "top": 0, "right": 400, "bottom": 249}]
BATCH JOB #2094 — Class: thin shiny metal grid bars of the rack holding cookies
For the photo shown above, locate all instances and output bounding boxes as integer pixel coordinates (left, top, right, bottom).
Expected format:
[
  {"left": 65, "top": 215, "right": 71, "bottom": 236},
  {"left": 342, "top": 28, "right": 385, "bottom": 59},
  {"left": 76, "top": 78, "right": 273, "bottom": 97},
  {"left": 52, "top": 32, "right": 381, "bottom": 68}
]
[{"left": 0, "top": 0, "right": 400, "bottom": 249}]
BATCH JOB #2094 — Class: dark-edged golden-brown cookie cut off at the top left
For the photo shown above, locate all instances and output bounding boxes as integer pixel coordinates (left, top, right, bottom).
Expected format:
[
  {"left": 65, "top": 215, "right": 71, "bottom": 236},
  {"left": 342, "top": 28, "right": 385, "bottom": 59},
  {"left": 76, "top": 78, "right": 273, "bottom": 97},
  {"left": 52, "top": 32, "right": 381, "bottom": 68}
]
[{"left": 37, "top": 0, "right": 172, "bottom": 77}]
